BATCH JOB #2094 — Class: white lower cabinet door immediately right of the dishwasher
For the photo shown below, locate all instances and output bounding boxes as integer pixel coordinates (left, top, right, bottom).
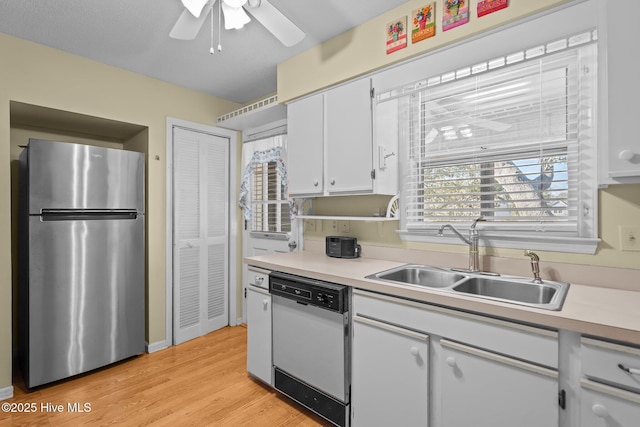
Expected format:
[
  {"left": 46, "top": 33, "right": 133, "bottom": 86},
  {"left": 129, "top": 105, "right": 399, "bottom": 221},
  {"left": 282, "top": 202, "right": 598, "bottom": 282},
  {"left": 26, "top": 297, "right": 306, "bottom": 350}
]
[{"left": 351, "top": 316, "right": 429, "bottom": 427}]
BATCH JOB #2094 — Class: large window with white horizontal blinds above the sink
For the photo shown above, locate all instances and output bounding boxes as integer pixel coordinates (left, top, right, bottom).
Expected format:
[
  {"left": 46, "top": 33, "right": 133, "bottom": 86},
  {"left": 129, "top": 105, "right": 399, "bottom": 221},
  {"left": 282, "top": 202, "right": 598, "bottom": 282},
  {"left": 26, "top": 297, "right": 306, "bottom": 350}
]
[{"left": 378, "top": 33, "right": 597, "bottom": 252}]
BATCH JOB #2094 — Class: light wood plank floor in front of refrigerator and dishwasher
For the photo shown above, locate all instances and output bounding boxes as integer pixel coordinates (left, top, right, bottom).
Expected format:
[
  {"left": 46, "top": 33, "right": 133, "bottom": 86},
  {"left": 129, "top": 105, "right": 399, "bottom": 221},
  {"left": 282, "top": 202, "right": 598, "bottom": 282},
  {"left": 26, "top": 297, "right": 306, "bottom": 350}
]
[{"left": 0, "top": 327, "right": 330, "bottom": 427}]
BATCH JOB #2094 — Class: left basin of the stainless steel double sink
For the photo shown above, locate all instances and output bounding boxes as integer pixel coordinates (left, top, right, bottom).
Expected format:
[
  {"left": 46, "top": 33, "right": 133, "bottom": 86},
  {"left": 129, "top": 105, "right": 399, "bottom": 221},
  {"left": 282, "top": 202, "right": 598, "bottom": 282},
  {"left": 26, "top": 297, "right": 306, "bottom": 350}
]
[{"left": 367, "top": 265, "right": 467, "bottom": 288}]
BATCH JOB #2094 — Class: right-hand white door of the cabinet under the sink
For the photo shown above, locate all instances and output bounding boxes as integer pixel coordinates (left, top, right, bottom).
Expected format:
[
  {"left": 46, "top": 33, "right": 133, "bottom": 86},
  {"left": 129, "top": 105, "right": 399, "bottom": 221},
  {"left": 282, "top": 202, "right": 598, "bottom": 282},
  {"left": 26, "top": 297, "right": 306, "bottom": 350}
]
[{"left": 438, "top": 340, "right": 559, "bottom": 427}]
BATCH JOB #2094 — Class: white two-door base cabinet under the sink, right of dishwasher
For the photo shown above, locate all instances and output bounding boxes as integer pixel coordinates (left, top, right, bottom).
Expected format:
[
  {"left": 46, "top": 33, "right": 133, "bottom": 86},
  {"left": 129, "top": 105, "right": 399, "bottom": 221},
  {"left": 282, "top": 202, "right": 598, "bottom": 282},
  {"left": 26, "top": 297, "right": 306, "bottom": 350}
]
[{"left": 351, "top": 289, "right": 560, "bottom": 427}]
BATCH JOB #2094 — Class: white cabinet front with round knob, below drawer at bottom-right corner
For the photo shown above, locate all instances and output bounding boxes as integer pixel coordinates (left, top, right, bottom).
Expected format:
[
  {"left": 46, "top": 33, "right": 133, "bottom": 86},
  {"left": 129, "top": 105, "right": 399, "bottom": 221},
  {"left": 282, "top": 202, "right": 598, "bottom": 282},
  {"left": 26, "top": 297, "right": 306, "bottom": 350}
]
[{"left": 580, "top": 381, "right": 640, "bottom": 427}]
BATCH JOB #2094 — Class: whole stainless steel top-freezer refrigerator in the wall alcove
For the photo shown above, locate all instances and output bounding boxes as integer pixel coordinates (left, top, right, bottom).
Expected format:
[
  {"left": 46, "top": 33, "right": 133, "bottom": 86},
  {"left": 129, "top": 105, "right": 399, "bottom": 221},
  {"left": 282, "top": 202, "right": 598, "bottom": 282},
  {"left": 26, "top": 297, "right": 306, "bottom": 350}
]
[{"left": 18, "top": 139, "right": 145, "bottom": 388}]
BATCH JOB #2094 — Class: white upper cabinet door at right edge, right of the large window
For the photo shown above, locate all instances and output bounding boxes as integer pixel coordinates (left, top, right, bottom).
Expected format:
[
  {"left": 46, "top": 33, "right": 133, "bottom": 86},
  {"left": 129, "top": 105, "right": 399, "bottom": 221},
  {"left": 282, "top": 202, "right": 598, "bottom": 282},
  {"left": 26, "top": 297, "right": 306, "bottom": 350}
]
[{"left": 606, "top": 0, "right": 640, "bottom": 182}]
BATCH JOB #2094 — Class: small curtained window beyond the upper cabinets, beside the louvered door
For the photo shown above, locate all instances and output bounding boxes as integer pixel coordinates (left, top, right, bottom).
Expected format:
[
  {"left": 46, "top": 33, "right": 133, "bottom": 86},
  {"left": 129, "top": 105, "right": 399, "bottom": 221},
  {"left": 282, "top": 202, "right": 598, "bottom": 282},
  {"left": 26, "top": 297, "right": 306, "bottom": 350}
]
[{"left": 251, "top": 161, "right": 291, "bottom": 233}]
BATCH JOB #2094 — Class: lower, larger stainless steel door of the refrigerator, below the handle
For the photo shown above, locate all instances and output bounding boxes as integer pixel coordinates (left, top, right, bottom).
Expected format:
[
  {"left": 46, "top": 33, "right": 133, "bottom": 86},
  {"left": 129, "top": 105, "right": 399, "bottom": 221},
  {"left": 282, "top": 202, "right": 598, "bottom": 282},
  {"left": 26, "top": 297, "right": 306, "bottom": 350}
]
[{"left": 25, "top": 216, "right": 145, "bottom": 387}]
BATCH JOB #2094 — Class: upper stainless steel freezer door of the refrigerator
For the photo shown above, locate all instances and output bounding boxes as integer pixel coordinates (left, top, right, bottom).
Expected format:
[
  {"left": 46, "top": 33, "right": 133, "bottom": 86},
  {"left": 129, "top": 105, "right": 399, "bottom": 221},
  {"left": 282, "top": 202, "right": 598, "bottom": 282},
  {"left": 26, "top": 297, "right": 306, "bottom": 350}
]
[{"left": 25, "top": 139, "right": 144, "bottom": 214}]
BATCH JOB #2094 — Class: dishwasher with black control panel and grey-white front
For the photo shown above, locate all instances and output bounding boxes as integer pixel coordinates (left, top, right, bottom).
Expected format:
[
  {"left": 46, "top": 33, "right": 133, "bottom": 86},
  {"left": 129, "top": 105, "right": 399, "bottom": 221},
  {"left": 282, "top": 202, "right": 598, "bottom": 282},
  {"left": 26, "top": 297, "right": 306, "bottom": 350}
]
[{"left": 269, "top": 272, "right": 351, "bottom": 426}]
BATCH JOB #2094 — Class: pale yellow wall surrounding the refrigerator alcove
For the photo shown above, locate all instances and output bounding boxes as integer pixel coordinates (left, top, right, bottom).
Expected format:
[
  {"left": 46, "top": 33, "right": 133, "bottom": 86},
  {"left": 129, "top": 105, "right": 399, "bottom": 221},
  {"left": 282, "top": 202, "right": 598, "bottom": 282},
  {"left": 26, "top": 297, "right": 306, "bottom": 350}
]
[{"left": 0, "top": 34, "right": 239, "bottom": 389}]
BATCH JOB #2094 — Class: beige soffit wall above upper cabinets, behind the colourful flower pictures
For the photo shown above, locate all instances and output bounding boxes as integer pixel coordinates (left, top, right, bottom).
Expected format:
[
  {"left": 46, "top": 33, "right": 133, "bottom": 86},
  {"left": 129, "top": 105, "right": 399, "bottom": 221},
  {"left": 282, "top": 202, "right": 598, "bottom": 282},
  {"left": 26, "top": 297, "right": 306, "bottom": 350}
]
[{"left": 278, "top": 0, "right": 569, "bottom": 102}]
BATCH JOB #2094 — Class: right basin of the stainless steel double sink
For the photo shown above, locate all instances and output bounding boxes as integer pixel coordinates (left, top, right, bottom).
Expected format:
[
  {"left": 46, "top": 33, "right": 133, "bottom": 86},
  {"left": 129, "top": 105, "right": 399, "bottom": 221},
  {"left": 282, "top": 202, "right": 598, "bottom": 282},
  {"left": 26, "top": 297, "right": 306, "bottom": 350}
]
[{"left": 453, "top": 276, "right": 569, "bottom": 310}]
